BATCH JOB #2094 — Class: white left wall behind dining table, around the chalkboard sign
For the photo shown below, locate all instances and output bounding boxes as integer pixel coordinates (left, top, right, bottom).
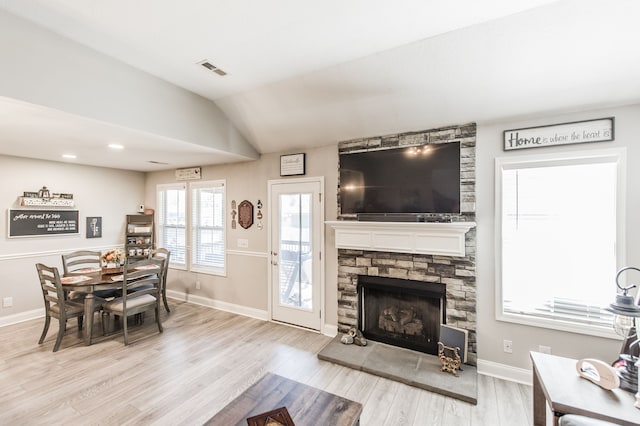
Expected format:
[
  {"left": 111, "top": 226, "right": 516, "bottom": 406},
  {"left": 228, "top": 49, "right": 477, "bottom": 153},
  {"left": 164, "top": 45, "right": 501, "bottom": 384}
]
[{"left": 0, "top": 156, "right": 144, "bottom": 325}]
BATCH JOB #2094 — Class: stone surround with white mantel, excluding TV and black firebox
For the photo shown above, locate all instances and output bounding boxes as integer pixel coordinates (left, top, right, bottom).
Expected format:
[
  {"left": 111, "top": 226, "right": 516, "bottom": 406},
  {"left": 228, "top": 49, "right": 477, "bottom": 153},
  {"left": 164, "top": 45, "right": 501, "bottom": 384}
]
[{"left": 328, "top": 123, "right": 477, "bottom": 365}]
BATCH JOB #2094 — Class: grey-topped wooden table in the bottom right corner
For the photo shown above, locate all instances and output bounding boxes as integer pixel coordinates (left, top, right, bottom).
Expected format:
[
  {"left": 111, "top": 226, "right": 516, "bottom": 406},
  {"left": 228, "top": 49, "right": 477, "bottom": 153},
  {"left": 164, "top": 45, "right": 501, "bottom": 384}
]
[{"left": 530, "top": 352, "right": 640, "bottom": 426}]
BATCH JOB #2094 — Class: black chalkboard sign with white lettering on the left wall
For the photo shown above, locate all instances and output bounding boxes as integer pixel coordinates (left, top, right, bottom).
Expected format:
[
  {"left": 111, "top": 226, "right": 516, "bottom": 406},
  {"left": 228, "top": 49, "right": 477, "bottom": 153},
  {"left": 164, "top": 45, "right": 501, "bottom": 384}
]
[{"left": 9, "top": 210, "right": 79, "bottom": 238}]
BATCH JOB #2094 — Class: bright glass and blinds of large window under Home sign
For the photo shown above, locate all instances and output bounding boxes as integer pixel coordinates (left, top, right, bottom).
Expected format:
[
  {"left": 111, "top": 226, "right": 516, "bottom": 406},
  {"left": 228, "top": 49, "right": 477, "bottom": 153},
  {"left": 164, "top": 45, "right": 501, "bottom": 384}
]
[{"left": 496, "top": 150, "right": 624, "bottom": 336}]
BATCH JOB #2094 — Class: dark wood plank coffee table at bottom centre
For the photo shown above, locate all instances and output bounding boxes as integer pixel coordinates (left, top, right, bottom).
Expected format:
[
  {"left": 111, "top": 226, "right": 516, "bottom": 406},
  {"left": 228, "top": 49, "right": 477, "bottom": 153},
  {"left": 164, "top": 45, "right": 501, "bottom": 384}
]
[{"left": 205, "top": 373, "right": 362, "bottom": 426}]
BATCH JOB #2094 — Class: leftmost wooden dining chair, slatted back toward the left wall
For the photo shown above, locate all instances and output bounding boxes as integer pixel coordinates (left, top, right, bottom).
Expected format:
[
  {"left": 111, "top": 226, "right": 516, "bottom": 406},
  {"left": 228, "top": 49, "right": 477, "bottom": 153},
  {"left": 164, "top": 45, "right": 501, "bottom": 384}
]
[{"left": 36, "top": 263, "right": 84, "bottom": 352}]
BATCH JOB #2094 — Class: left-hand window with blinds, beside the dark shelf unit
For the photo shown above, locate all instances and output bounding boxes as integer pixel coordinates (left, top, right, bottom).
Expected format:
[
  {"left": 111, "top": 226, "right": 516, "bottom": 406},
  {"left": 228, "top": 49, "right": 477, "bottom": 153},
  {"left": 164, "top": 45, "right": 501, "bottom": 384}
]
[{"left": 156, "top": 184, "right": 187, "bottom": 269}]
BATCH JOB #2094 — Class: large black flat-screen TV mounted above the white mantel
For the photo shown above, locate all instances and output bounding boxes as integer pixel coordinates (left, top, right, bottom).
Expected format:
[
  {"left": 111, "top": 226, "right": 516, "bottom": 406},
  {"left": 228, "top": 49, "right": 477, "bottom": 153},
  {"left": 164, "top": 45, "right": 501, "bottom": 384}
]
[{"left": 340, "top": 142, "right": 460, "bottom": 215}]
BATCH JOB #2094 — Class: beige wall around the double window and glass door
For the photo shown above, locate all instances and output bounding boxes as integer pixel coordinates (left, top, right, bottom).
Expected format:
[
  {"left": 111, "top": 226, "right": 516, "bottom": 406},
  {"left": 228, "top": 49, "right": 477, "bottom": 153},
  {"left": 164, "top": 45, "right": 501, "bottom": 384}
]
[{"left": 145, "top": 145, "right": 338, "bottom": 325}]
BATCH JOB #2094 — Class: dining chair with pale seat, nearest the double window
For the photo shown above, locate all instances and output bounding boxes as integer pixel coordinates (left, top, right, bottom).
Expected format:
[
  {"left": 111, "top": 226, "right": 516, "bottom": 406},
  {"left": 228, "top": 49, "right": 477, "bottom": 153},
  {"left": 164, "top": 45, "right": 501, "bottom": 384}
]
[{"left": 102, "top": 258, "right": 165, "bottom": 345}]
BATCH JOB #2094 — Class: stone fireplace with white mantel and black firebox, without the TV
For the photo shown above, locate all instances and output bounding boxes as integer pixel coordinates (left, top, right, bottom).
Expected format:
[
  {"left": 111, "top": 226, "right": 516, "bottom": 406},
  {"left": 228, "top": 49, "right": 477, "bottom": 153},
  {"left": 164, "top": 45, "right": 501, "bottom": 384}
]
[{"left": 328, "top": 124, "right": 477, "bottom": 365}]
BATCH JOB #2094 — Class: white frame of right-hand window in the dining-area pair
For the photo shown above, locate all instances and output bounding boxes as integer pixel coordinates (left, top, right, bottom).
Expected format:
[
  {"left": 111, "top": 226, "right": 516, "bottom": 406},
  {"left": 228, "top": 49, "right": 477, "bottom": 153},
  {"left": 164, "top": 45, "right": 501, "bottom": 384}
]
[{"left": 189, "top": 179, "right": 227, "bottom": 276}]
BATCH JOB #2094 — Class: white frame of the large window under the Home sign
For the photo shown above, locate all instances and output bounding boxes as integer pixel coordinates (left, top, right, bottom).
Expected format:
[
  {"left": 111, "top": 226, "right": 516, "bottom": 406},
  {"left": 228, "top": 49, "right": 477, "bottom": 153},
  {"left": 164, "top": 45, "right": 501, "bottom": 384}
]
[{"left": 495, "top": 148, "right": 626, "bottom": 339}]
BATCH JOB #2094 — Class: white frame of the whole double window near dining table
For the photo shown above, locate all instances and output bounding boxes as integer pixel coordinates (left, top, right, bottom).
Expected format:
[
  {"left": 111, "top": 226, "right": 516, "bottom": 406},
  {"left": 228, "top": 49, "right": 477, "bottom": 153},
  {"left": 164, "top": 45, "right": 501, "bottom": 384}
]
[{"left": 156, "top": 180, "right": 227, "bottom": 276}]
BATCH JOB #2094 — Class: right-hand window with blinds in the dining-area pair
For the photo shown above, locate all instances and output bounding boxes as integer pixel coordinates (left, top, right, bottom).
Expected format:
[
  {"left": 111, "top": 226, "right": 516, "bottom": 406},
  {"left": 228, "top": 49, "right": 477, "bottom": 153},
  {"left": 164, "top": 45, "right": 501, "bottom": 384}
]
[{"left": 191, "top": 181, "right": 226, "bottom": 275}]
